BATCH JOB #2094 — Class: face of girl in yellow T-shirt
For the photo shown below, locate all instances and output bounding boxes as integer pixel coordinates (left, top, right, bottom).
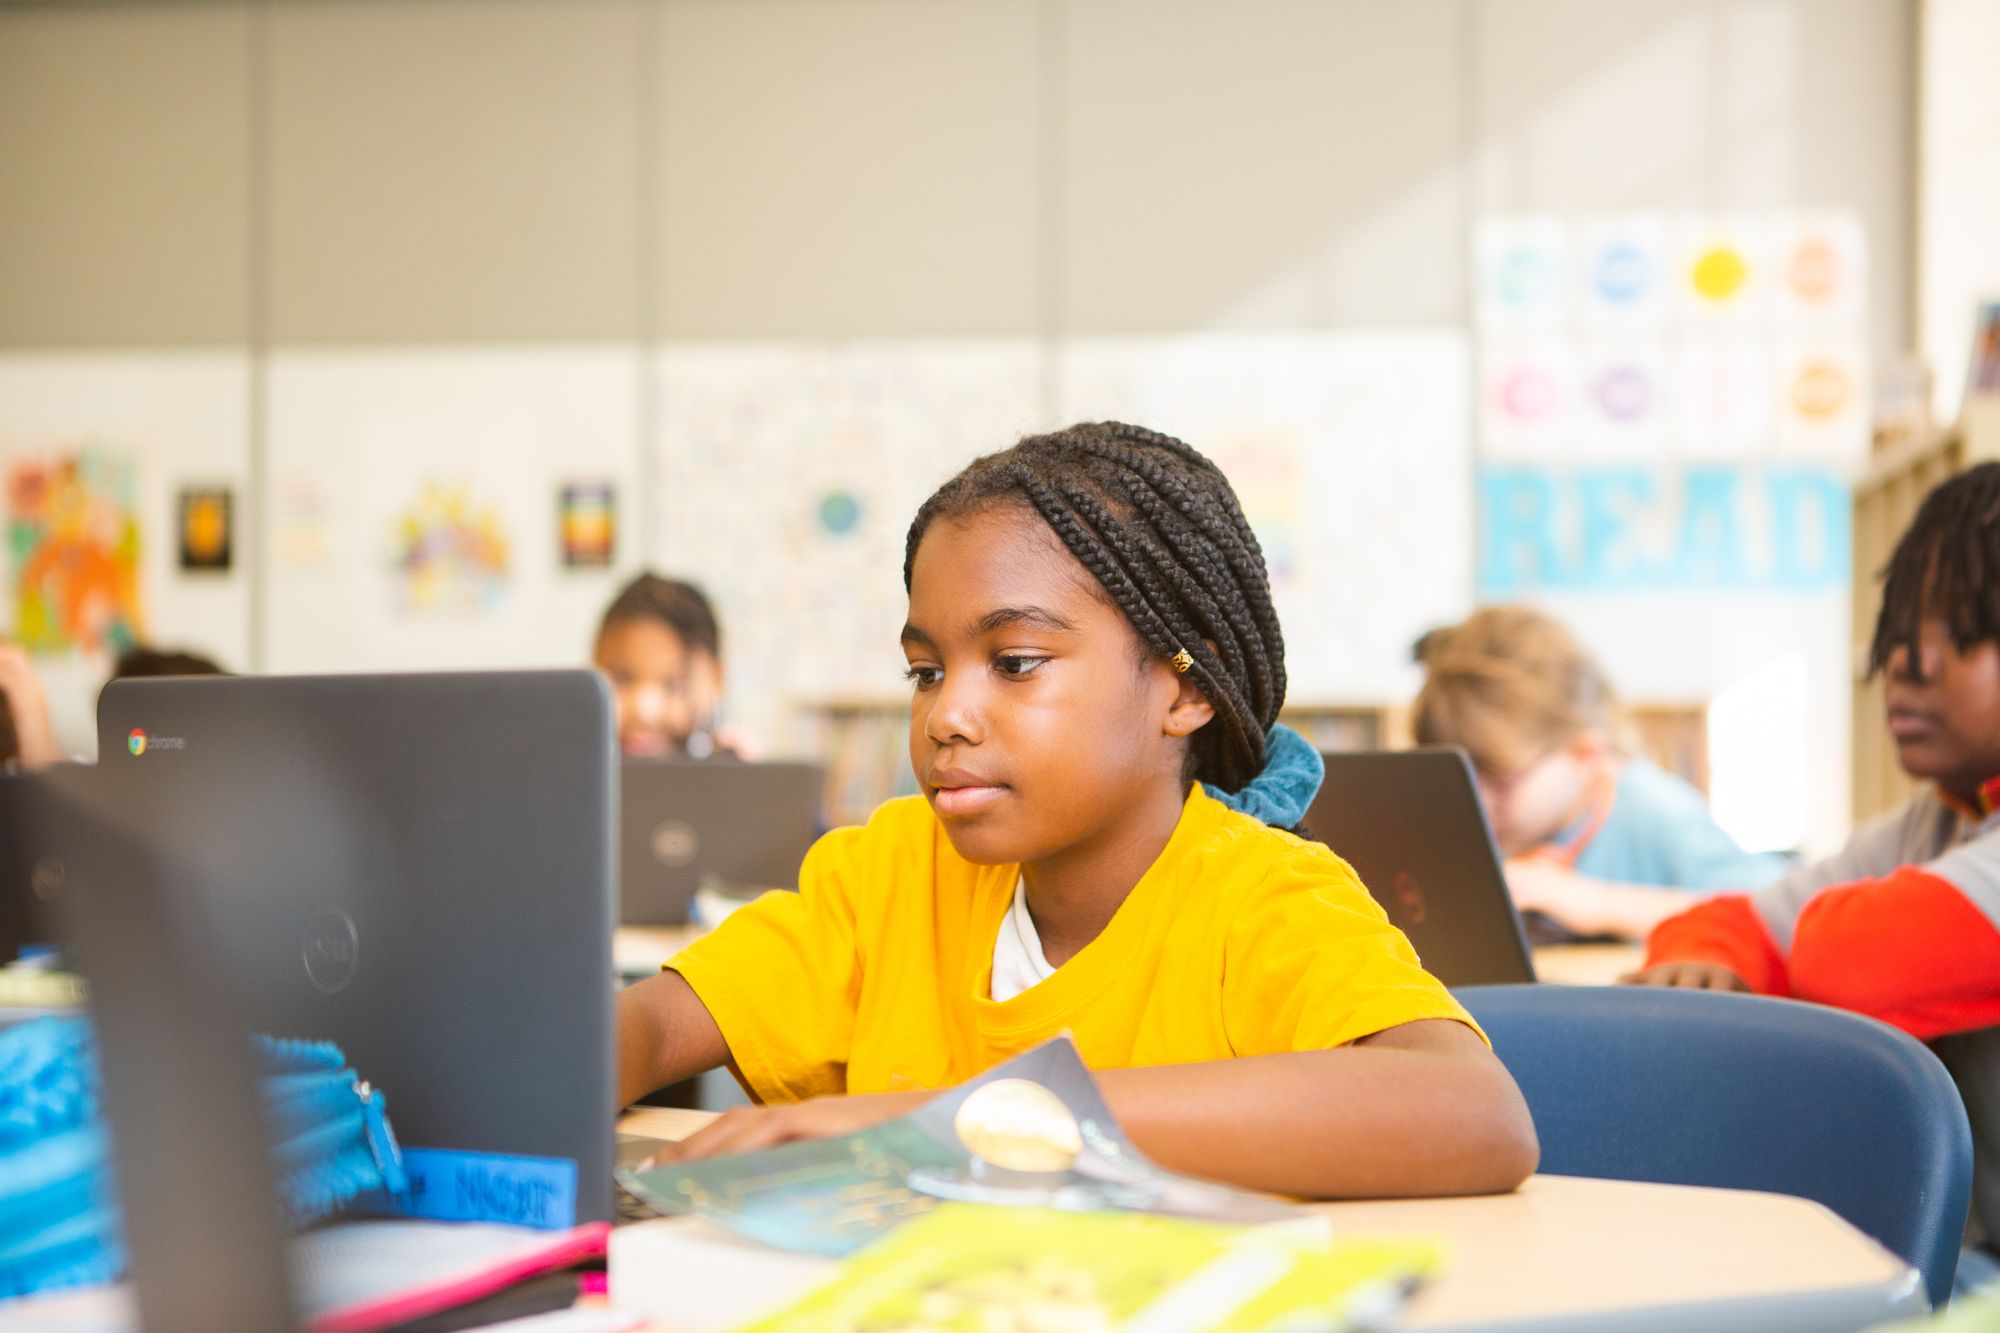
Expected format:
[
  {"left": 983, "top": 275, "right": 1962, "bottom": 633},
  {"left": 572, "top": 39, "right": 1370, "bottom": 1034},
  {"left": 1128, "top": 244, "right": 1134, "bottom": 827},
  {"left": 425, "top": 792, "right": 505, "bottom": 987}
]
[{"left": 902, "top": 506, "right": 1214, "bottom": 865}]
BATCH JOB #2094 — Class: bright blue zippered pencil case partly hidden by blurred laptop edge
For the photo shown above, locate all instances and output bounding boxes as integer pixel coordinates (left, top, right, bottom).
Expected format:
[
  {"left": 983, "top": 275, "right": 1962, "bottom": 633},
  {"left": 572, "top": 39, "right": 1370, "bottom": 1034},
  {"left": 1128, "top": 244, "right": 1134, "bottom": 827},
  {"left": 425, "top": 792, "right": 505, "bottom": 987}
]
[{"left": 0, "top": 1019, "right": 408, "bottom": 1301}]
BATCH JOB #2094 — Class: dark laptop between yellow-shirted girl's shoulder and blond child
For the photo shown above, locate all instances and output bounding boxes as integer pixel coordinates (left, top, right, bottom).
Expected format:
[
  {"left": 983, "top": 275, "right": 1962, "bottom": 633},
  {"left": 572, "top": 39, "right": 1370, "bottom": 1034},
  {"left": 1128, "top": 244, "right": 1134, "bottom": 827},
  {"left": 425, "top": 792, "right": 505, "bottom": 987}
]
[{"left": 1306, "top": 749, "right": 1534, "bottom": 987}]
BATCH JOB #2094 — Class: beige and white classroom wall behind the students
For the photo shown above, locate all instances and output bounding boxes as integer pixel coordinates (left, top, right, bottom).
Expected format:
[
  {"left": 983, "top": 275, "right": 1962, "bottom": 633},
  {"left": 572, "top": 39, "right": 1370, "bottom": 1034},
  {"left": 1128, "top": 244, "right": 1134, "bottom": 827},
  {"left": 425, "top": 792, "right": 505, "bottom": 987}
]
[{"left": 0, "top": 0, "right": 1914, "bottom": 845}]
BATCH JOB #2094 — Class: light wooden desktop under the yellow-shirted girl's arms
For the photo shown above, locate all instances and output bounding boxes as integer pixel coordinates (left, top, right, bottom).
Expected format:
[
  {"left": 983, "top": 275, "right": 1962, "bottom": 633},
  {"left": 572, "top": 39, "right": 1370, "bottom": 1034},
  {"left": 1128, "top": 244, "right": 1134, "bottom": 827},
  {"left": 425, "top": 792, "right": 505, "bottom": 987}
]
[{"left": 620, "top": 1109, "right": 1924, "bottom": 1333}]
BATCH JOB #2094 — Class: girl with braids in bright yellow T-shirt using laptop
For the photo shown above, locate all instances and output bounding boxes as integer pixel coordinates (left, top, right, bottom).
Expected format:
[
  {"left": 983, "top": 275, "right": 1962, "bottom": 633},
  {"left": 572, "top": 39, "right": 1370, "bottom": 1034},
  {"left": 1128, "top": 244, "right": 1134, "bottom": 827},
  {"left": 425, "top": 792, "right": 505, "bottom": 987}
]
[{"left": 618, "top": 422, "right": 1536, "bottom": 1195}]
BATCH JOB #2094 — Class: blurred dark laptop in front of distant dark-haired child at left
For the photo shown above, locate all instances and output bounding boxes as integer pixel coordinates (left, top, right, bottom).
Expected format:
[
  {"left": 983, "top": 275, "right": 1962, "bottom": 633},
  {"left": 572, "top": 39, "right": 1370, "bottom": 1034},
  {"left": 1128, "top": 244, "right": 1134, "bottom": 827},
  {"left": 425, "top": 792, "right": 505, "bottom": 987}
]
[{"left": 618, "top": 759, "right": 826, "bottom": 925}]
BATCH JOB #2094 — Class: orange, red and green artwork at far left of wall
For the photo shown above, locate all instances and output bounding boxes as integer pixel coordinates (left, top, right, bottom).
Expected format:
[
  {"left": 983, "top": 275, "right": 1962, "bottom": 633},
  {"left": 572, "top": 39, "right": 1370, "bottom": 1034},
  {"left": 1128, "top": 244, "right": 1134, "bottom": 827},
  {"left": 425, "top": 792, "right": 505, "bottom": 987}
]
[{"left": 6, "top": 446, "right": 144, "bottom": 654}]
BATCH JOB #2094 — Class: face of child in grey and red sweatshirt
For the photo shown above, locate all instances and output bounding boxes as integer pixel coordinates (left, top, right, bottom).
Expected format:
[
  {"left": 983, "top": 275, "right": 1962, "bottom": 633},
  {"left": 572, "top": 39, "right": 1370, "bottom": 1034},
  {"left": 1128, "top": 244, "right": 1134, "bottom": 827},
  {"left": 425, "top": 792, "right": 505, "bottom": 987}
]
[{"left": 1882, "top": 618, "right": 2000, "bottom": 801}]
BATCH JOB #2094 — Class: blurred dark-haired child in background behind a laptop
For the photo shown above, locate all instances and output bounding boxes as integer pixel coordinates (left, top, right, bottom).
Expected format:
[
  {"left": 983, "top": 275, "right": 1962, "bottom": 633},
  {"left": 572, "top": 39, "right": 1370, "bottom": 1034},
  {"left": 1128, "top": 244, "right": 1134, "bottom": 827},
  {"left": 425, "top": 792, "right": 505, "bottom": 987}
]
[{"left": 592, "top": 574, "right": 752, "bottom": 759}]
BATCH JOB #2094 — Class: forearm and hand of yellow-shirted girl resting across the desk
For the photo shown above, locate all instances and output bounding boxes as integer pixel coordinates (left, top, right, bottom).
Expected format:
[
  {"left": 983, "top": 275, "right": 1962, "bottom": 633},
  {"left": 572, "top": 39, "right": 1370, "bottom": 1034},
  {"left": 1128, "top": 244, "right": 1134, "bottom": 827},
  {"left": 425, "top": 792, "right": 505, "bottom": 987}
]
[{"left": 648, "top": 1016, "right": 1540, "bottom": 1197}]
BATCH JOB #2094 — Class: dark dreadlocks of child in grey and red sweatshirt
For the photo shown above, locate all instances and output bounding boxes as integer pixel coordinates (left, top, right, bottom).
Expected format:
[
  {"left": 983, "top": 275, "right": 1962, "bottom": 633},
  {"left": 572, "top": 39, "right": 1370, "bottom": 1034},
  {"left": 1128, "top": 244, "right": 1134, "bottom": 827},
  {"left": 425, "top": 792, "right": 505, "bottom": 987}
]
[{"left": 1868, "top": 462, "right": 2000, "bottom": 675}]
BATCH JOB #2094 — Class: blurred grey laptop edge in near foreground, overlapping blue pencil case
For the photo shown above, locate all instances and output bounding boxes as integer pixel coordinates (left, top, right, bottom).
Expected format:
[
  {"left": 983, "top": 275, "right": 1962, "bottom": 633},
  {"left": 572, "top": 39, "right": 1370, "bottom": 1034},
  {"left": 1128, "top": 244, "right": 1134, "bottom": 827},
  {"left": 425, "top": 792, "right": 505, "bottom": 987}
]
[{"left": 38, "top": 769, "right": 298, "bottom": 1333}]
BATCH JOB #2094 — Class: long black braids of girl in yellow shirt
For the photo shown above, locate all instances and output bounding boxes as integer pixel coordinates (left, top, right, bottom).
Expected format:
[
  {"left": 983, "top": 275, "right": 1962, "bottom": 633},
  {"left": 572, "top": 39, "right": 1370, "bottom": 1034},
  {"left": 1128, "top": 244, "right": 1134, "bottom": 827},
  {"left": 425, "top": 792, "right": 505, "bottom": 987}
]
[{"left": 902, "top": 420, "right": 1284, "bottom": 791}]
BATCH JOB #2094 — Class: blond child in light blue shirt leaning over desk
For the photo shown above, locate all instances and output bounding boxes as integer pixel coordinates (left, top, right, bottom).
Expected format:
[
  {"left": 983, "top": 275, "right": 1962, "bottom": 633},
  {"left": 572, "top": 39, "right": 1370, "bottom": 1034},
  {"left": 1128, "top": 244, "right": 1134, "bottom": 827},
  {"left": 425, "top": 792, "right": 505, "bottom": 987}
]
[{"left": 1414, "top": 606, "right": 1786, "bottom": 939}]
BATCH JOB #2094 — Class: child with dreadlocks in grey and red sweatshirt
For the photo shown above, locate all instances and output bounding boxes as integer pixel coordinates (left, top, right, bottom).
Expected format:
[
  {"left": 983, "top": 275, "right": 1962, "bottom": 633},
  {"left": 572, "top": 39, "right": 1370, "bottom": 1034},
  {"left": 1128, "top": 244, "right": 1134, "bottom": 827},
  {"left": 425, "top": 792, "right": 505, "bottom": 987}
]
[{"left": 1632, "top": 462, "right": 2000, "bottom": 1237}]
